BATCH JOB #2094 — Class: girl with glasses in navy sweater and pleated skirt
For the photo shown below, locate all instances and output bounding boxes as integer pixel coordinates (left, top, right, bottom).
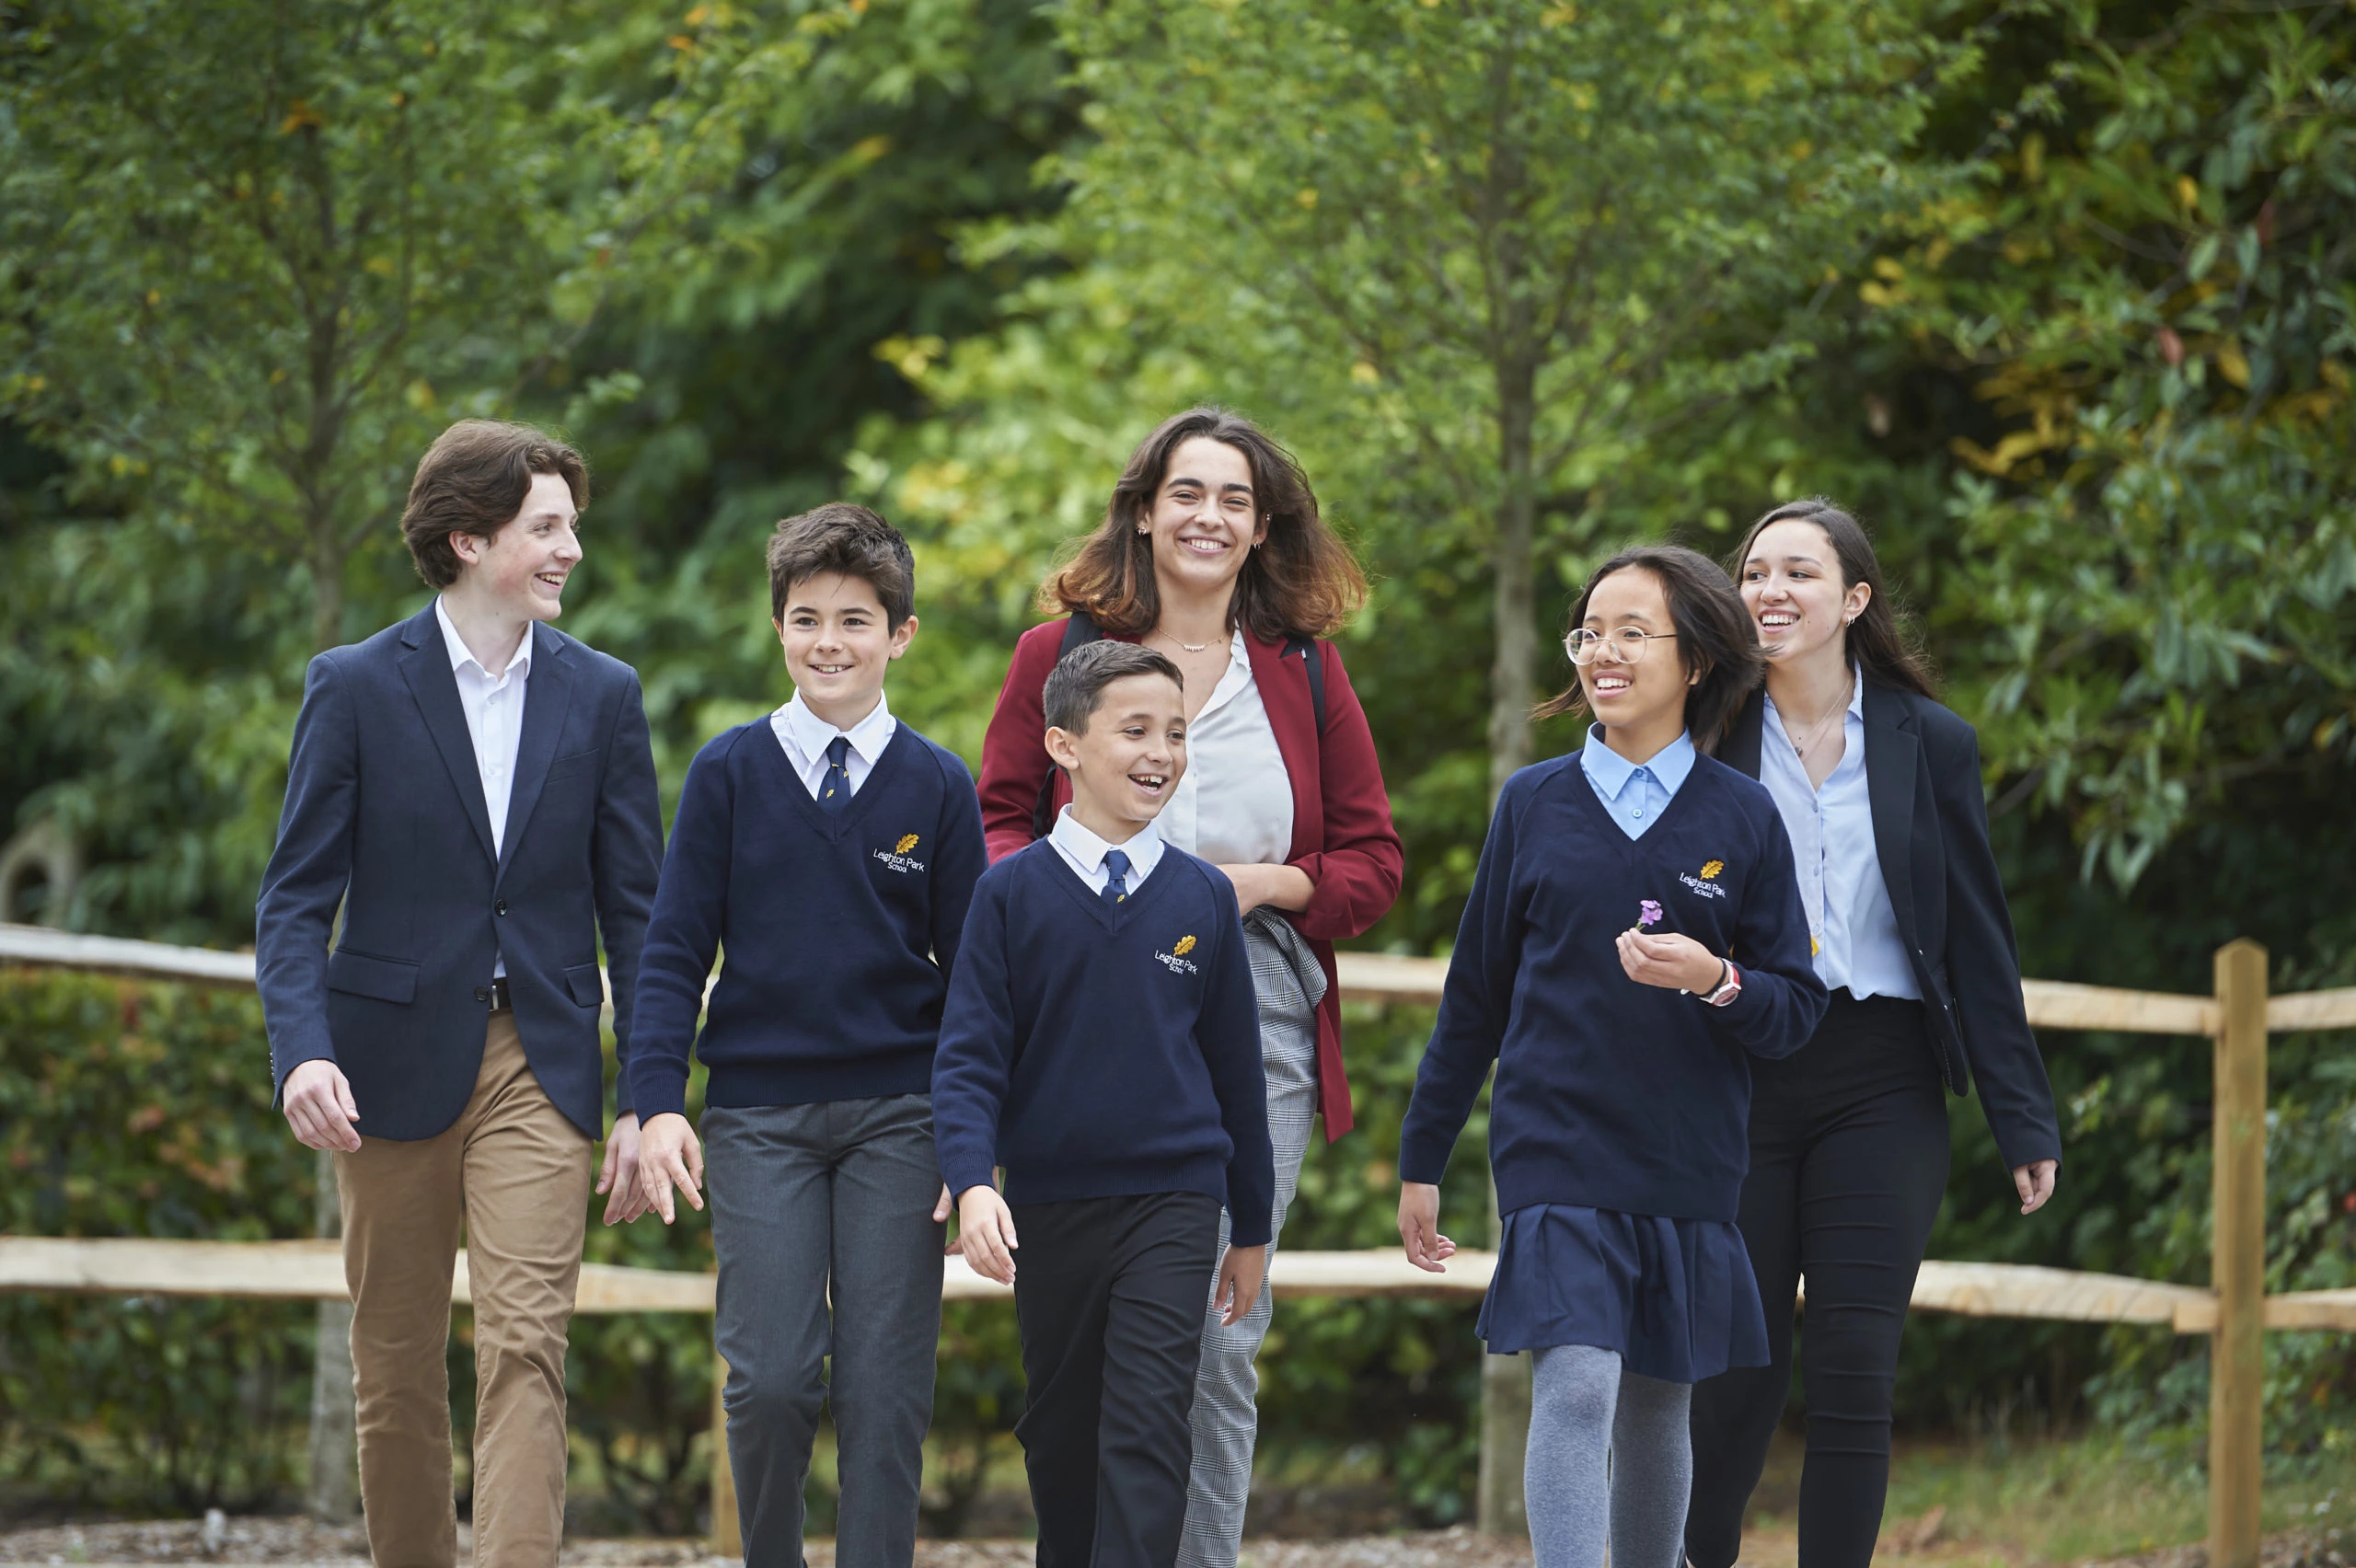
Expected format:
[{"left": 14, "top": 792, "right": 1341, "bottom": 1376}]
[{"left": 1400, "top": 548, "right": 1823, "bottom": 1568}]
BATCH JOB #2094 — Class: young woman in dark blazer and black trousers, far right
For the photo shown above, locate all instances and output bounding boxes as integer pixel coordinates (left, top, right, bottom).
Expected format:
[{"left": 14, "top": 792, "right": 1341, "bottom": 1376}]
[{"left": 1684, "top": 499, "right": 2062, "bottom": 1568}]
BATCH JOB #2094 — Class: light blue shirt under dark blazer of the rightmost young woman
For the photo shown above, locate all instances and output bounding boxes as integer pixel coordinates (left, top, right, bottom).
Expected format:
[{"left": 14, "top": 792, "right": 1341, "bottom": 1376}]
[{"left": 1760, "top": 678, "right": 1923, "bottom": 1000}]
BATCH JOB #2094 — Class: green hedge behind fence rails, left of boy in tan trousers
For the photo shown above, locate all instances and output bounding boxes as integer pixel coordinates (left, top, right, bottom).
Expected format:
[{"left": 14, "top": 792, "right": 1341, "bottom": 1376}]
[{"left": 0, "top": 973, "right": 313, "bottom": 1509}]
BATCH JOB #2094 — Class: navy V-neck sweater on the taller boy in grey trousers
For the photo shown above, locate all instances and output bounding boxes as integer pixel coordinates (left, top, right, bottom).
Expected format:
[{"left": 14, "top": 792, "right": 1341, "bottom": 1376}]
[{"left": 629, "top": 716, "right": 987, "bottom": 1116}]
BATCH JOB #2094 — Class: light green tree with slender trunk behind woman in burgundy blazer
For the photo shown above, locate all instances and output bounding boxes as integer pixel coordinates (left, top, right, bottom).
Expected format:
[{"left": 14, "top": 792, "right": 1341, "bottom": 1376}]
[{"left": 1065, "top": 0, "right": 1941, "bottom": 789}]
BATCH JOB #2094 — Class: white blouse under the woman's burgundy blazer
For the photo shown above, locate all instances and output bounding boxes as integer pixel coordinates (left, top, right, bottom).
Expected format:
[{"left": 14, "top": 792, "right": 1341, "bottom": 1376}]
[{"left": 1154, "top": 631, "right": 1293, "bottom": 867}]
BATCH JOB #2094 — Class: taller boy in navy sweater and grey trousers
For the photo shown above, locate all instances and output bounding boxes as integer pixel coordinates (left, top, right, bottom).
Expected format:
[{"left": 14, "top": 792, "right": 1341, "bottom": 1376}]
[{"left": 631, "top": 502, "right": 985, "bottom": 1568}]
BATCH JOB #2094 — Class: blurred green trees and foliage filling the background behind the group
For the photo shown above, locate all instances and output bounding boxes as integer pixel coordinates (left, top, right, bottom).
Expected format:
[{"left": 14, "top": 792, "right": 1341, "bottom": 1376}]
[{"left": 0, "top": 0, "right": 2356, "bottom": 1521}]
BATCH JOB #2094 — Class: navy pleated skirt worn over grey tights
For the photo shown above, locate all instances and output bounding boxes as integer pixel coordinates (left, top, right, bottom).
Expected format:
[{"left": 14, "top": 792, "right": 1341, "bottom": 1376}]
[{"left": 1477, "top": 1203, "right": 1767, "bottom": 1382}]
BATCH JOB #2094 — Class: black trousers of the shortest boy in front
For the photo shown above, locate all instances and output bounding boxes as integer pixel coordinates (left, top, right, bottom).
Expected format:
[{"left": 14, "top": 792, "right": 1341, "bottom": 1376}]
[{"left": 1013, "top": 1192, "right": 1218, "bottom": 1568}]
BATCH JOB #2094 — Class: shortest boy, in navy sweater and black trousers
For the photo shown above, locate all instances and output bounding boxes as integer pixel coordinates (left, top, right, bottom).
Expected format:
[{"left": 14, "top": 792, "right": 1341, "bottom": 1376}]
[{"left": 933, "top": 640, "right": 1275, "bottom": 1568}]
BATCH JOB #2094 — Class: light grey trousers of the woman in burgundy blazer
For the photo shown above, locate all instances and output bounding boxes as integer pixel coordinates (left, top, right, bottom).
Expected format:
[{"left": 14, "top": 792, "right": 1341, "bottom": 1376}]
[{"left": 1178, "top": 911, "right": 1324, "bottom": 1568}]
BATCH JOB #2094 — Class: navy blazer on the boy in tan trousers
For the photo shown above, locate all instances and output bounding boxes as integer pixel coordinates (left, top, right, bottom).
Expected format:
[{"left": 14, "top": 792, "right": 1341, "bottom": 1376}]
[{"left": 254, "top": 605, "right": 662, "bottom": 1139}]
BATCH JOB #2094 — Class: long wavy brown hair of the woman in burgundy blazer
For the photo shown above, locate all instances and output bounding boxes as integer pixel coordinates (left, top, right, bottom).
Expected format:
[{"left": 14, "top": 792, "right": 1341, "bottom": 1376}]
[{"left": 1039, "top": 408, "right": 1367, "bottom": 642}]
